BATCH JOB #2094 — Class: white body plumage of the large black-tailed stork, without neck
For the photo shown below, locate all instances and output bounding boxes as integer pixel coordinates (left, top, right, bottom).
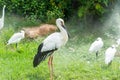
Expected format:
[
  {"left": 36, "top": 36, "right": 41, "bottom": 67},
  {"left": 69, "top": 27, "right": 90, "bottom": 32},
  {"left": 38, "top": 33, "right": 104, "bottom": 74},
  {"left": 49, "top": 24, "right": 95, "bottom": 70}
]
[{"left": 41, "top": 32, "right": 68, "bottom": 52}]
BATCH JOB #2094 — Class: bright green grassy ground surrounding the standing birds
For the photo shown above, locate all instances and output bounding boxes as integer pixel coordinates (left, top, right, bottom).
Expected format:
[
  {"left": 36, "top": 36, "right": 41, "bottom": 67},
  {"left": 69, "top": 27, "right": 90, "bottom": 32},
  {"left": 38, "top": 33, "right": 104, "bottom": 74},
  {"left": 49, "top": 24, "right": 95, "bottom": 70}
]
[{"left": 0, "top": 16, "right": 120, "bottom": 80}]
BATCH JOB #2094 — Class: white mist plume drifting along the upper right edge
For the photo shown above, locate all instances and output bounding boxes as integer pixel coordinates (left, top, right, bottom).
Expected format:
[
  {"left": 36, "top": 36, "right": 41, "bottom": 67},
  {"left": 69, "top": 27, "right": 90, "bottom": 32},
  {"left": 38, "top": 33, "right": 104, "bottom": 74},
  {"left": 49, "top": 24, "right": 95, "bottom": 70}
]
[{"left": 103, "top": 4, "right": 120, "bottom": 39}]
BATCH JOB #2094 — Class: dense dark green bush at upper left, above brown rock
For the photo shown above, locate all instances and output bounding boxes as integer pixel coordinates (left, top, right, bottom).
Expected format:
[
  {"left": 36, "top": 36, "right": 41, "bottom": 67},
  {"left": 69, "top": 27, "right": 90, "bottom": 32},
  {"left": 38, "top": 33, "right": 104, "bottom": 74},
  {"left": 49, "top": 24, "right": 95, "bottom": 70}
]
[{"left": 0, "top": 0, "right": 72, "bottom": 22}]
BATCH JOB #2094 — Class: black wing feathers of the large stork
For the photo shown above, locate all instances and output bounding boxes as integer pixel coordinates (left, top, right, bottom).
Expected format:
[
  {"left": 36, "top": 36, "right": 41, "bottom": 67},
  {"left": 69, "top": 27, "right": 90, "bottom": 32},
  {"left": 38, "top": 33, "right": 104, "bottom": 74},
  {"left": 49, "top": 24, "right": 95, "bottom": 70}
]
[{"left": 33, "top": 43, "right": 57, "bottom": 67}]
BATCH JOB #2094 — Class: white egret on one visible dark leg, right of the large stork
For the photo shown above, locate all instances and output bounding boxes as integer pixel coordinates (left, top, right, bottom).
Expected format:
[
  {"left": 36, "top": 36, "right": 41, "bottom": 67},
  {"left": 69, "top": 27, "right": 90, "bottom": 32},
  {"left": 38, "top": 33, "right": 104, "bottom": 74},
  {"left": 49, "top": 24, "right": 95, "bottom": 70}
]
[{"left": 89, "top": 37, "right": 103, "bottom": 57}]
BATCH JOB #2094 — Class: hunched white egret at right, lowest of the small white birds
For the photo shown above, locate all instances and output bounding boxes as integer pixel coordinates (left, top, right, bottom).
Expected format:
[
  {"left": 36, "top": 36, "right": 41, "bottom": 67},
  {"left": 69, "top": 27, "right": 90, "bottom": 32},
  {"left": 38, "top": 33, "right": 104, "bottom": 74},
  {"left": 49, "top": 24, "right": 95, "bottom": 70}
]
[{"left": 105, "top": 45, "right": 117, "bottom": 65}]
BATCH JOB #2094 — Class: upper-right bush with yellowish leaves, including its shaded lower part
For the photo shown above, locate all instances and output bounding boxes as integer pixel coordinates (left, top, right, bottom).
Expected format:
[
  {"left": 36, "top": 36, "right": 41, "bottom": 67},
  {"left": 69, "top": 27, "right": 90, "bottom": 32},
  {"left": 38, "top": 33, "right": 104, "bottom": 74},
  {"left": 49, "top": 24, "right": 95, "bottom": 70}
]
[{"left": 75, "top": 0, "right": 117, "bottom": 28}]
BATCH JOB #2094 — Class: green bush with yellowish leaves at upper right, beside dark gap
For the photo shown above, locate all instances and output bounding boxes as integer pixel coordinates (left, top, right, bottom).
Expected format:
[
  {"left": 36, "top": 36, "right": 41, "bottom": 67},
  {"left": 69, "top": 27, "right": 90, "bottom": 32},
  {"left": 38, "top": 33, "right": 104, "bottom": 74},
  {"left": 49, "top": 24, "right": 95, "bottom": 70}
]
[{"left": 78, "top": 0, "right": 117, "bottom": 19}]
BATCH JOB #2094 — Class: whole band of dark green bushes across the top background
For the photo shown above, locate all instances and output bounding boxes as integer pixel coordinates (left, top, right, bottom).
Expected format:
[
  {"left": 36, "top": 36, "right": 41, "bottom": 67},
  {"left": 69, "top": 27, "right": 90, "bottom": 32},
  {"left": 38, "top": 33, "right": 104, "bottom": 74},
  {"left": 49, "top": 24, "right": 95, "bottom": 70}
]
[{"left": 0, "top": 0, "right": 119, "bottom": 22}]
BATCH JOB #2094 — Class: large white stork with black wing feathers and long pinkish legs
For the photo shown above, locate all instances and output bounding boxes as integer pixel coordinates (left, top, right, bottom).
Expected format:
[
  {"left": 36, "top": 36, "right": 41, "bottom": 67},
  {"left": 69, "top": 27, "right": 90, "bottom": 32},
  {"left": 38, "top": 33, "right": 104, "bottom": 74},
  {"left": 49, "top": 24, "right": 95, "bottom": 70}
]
[{"left": 33, "top": 18, "right": 68, "bottom": 80}]
